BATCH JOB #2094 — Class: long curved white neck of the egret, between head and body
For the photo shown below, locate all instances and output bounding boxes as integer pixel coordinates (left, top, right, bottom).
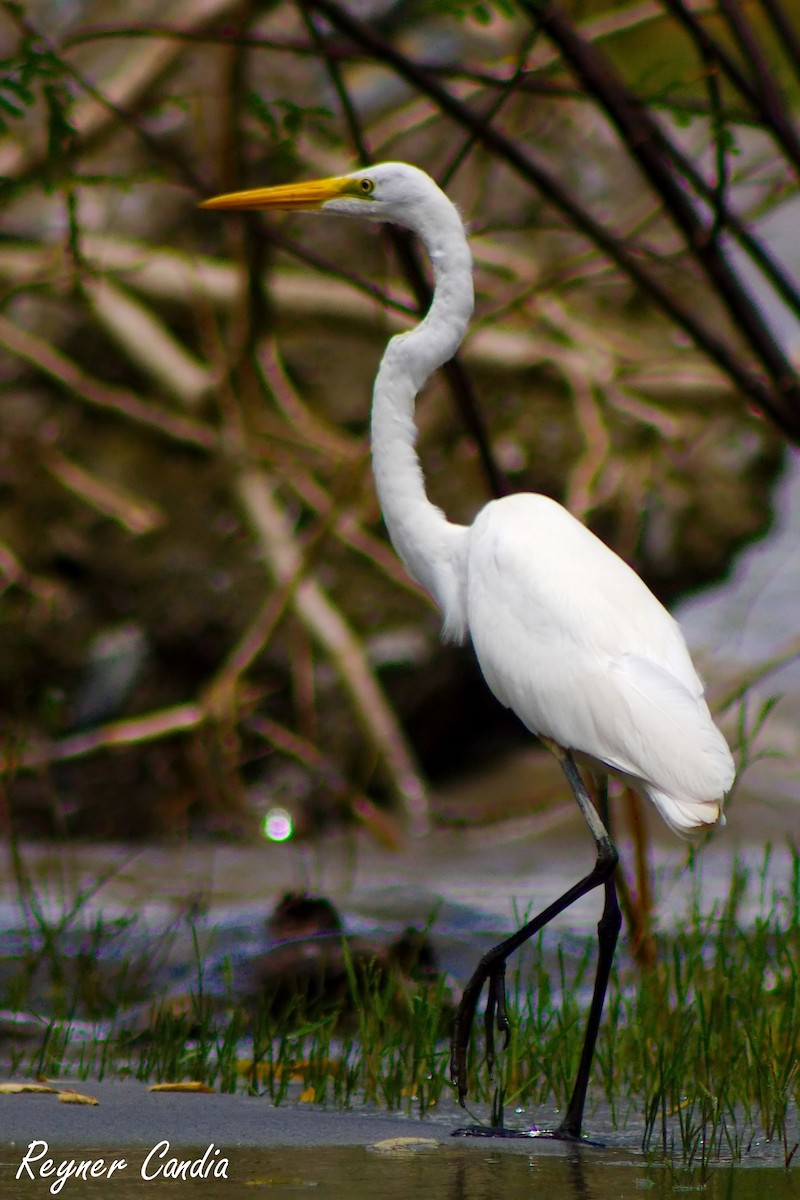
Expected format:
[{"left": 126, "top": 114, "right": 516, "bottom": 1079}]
[{"left": 372, "top": 192, "right": 474, "bottom": 641}]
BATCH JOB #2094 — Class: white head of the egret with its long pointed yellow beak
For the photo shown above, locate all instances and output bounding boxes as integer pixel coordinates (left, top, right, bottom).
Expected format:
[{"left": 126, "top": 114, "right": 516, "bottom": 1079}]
[{"left": 200, "top": 162, "right": 452, "bottom": 238}]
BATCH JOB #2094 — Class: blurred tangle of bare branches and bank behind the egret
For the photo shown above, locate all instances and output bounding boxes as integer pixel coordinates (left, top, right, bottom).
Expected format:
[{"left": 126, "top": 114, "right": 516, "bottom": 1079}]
[{"left": 0, "top": 0, "right": 800, "bottom": 873}]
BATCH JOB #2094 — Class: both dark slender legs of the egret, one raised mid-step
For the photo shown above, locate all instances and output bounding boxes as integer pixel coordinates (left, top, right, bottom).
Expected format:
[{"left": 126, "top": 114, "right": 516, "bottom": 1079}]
[{"left": 450, "top": 739, "right": 621, "bottom": 1141}]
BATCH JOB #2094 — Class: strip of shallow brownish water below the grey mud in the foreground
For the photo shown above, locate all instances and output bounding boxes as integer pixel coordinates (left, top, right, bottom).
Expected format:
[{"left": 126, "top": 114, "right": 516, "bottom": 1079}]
[{"left": 0, "top": 1145, "right": 800, "bottom": 1200}]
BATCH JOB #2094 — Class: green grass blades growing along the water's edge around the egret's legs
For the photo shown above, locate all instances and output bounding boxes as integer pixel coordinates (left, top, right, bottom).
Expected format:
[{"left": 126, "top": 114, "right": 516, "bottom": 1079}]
[{"left": 1, "top": 850, "right": 800, "bottom": 1166}]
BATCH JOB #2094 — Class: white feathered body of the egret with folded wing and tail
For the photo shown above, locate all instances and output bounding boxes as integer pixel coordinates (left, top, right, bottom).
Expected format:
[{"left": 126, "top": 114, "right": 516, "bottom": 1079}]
[{"left": 468, "top": 493, "right": 734, "bottom": 833}]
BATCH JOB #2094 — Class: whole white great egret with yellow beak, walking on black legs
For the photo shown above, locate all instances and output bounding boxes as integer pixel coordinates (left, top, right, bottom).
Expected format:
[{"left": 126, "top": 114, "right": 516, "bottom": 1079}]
[{"left": 203, "top": 162, "right": 734, "bottom": 1140}]
